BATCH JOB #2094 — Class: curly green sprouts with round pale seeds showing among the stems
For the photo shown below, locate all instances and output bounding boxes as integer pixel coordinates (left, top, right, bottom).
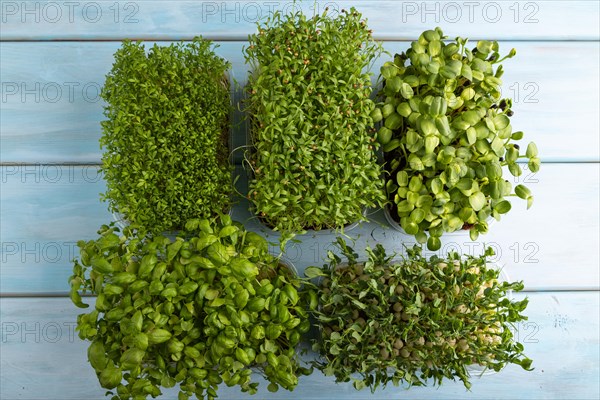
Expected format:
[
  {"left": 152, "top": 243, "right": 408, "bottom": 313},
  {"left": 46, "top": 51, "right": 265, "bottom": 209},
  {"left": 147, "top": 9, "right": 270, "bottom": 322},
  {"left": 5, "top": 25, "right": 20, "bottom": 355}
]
[{"left": 306, "top": 239, "right": 531, "bottom": 390}]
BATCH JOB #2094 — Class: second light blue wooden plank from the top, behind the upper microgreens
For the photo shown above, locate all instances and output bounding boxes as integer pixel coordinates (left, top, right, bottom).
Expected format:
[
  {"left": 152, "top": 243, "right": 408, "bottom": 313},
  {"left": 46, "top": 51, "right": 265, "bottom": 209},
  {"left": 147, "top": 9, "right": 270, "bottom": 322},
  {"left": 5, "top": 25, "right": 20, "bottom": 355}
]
[{"left": 0, "top": 42, "right": 600, "bottom": 163}]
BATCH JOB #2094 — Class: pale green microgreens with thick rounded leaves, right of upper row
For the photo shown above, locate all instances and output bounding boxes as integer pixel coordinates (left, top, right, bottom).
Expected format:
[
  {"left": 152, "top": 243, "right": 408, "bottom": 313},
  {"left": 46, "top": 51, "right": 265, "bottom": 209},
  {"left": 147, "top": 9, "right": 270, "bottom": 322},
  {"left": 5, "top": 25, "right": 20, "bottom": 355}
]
[{"left": 373, "top": 28, "right": 540, "bottom": 250}]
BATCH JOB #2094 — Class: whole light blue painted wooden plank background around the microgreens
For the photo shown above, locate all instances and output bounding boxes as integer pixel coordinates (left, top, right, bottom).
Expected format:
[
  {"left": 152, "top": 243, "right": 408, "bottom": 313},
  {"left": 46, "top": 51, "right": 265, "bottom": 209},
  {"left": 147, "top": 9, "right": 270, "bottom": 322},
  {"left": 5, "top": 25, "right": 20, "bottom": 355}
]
[{"left": 0, "top": 0, "right": 600, "bottom": 400}]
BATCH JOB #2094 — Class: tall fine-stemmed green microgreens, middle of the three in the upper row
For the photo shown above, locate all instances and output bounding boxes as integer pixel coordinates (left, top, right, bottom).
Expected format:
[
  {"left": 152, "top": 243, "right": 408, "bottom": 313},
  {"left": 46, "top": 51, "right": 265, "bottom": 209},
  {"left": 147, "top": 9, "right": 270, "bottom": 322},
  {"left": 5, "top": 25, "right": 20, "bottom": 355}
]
[{"left": 245, "top": 9, "right": 385, "bottom": 232}]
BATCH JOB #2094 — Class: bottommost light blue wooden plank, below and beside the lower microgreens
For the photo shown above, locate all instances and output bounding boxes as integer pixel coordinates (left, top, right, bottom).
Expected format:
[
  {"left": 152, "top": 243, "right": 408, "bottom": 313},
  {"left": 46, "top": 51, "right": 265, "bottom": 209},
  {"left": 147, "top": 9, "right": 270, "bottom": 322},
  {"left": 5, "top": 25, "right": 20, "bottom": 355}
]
[{"left": 0, "top": 292, "right": 600, "bottom": 400}]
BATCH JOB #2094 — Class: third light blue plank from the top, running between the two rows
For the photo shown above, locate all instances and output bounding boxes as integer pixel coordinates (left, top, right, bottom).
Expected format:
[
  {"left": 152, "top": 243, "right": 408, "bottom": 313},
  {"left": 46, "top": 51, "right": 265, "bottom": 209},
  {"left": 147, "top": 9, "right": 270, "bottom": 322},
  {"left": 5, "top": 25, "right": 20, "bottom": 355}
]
[{"left": 0, "top": 164, "right": 600, "bottom": 294}]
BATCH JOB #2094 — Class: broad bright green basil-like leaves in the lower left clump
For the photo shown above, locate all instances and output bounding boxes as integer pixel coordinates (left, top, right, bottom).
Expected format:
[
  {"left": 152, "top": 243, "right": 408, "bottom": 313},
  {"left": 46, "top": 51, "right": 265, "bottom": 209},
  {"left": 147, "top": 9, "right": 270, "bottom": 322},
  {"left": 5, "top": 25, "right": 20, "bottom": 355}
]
[{"left": 70, "top": 215, "right": 311, "bottom": 400}]
